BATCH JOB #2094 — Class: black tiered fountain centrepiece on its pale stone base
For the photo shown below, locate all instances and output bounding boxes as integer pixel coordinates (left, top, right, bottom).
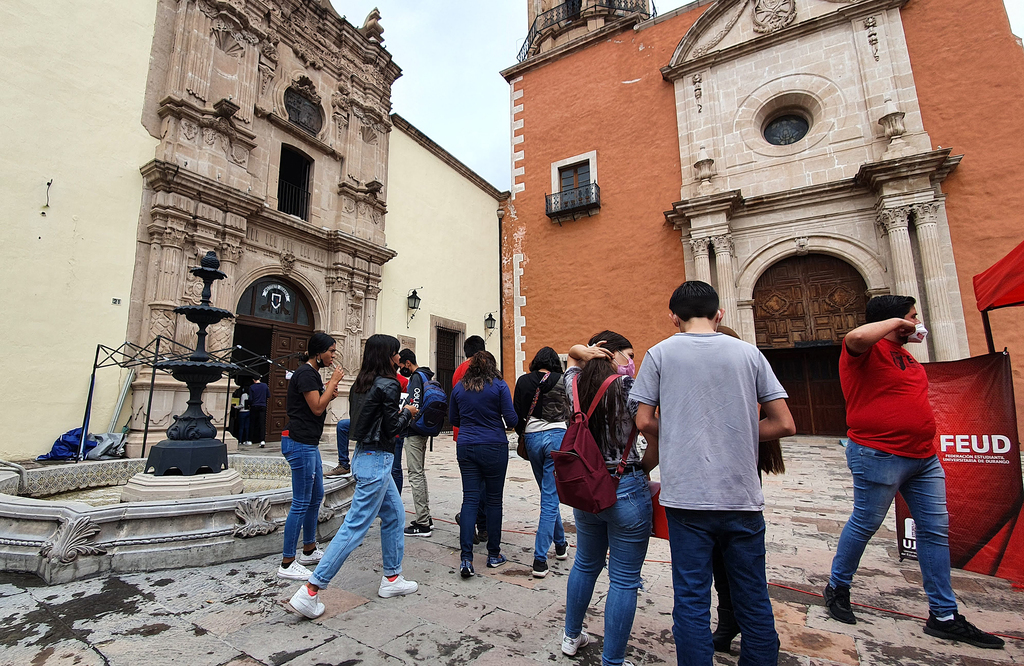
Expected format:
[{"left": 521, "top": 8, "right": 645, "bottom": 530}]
[{"left": 121, "top": 250, "right": 242, "bottom": 502}]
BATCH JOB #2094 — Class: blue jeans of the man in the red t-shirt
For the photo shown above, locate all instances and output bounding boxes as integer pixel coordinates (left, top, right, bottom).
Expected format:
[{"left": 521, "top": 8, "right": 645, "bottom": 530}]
[{"left": 829, "top": 440, "right": 956, "bottom": 618}]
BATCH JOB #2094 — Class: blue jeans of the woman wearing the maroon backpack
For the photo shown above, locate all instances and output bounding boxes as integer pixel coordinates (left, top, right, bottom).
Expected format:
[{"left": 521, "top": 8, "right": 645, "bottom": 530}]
[{"left": 565, "top": 471, "right": 651, "bottom": 666}]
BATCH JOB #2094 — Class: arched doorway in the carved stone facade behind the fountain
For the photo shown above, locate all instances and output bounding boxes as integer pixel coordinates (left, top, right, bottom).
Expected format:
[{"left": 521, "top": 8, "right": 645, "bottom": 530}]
[{"left": 233, "top": 277, "right": 313, "bottom": 442}]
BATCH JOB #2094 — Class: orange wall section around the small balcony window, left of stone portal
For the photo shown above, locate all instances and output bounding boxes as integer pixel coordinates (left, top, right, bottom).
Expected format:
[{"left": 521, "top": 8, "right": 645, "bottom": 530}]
[{"left": 504, "top": 8, "right": 702, "bottom": 380}]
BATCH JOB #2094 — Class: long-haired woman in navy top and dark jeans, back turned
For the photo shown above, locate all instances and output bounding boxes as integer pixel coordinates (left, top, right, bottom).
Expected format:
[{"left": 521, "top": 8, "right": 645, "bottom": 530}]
[{"left": 449, "top": 351, "right": 519, "bottom": 578}]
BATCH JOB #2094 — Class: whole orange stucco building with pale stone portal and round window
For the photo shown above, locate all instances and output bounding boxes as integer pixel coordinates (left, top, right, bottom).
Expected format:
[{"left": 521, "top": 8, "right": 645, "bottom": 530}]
[{"left": 503, "top": 0, "right": 1024, "bottom": 433}]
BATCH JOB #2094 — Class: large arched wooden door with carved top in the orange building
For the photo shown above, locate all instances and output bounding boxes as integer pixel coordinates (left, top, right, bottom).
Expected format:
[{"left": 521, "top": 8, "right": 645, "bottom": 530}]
[{"left": 754, "top": 254, "right": 867, "bottom": 434}]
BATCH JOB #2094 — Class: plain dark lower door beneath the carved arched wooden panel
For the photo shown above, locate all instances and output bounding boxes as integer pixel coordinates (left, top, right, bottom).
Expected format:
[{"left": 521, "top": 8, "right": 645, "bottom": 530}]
[{"left": 764, "top": 345, "right": 846, "bottom": 435}]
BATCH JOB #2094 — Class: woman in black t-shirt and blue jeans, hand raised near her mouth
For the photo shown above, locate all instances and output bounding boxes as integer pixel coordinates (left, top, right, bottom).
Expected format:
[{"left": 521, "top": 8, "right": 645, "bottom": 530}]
[{"left": 278, "top": 333, "right": 345, "bottom": 580}]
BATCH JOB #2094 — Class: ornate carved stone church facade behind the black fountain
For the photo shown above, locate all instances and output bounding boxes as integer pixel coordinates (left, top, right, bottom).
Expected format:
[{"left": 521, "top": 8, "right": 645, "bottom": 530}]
[{"left": 128, "top": 0, "right": 400, "bottom": 455}]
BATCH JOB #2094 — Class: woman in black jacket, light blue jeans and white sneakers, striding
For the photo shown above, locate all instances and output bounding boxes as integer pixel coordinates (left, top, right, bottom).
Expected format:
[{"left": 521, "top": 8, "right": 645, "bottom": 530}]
[{"left": 291, "top": 334, "right": 419, "bottom": 619}]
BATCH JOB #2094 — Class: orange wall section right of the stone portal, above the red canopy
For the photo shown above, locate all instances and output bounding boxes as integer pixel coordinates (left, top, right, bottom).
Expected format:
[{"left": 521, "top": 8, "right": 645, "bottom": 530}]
[{"left": 903, "top": 0, "right": 1024, "bottom": 427}]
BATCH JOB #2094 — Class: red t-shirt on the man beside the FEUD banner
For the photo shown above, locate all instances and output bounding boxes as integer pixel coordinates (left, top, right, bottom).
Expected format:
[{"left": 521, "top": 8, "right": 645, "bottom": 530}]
[{"left": 839, "top": 338, "right": 938, "bottom": 458}]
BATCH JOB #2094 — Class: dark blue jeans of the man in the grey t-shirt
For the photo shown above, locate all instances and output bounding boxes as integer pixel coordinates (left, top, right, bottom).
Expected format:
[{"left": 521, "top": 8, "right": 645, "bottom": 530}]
[{"left": 666, "top": 507, "right": 778, "bottom": 666}]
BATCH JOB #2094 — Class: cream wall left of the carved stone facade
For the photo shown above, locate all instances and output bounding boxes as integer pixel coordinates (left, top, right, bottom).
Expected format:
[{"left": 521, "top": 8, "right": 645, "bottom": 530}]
[{"left": 0, "top": 0, "right": 157, "bottom": 460}]
